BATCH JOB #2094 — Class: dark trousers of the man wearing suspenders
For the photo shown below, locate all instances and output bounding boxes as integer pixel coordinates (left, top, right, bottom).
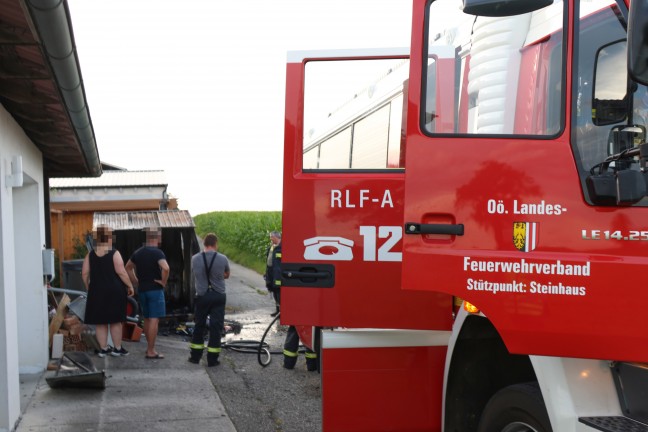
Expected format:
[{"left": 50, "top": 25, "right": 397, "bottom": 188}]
[{"left": 191, "top": 290, "right": 227, "bottom": 353}]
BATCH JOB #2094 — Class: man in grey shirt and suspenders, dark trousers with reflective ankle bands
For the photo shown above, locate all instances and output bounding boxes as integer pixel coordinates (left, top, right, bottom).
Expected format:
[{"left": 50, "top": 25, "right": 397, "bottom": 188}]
[{"left": 189, "top": 233, "right": 230, "bottom": 367}]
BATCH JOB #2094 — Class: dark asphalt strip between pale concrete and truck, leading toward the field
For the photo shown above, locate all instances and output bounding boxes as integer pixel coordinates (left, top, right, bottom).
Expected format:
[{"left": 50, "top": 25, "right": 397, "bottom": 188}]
[{"left": 207, "top": 264, "right": 322, "bottom": 432}]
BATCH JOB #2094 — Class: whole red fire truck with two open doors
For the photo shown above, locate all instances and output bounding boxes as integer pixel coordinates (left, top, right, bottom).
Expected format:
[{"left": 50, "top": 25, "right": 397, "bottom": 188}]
[{"left": 281, "top": 0, "right": 648, "bottom": 432}]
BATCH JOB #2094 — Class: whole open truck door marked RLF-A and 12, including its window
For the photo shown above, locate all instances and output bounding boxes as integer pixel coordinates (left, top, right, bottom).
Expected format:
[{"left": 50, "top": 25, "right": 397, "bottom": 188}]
[{"left": 281, "top": 49, "right": 452, "bottom": 330}]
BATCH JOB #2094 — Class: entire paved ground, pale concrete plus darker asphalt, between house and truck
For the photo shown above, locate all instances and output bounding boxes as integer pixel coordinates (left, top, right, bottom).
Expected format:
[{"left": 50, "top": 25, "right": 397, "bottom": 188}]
[{"left": 17, "top": 263, "right": 322, "bottom": 432}]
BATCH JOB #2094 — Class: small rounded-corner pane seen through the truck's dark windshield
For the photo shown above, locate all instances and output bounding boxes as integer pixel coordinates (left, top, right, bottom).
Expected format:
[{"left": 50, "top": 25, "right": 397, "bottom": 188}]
[{"left": 592, "top": 40, "right": 628, "bottom": 126}]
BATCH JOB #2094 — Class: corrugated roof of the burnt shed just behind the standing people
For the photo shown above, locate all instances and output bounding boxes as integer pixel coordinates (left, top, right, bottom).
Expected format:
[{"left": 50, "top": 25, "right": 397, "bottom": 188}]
[{"left": 92, "top": 210, "right": 196, "bottom": 231}]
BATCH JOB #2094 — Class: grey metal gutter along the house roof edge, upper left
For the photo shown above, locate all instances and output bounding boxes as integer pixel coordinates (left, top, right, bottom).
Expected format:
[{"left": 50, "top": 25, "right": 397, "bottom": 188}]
[{"left": 25, "top": 0, "right": 102, "bottom": 177}]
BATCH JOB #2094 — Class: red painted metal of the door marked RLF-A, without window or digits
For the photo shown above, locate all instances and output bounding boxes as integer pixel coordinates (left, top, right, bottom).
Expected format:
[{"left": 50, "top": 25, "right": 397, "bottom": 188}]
[{"left": 281, "top": 54, "right": 452, "bottom": 329}]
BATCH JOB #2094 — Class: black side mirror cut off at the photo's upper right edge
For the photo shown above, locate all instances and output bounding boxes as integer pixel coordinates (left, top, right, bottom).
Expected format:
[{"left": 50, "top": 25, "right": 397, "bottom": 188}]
[{"left": 628, "top": 1, "right": 648, "bottom": 85}]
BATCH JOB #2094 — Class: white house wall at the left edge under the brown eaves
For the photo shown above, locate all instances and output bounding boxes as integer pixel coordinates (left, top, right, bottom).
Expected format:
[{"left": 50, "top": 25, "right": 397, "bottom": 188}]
[{"left": 0, "top": 106, "right": 48, "bottom": 431}]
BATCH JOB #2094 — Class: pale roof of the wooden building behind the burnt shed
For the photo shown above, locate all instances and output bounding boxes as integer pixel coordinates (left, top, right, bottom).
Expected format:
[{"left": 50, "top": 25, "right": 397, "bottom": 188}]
[{"left": 50, "top": 170, "right": 168, "bottom": 189}]
